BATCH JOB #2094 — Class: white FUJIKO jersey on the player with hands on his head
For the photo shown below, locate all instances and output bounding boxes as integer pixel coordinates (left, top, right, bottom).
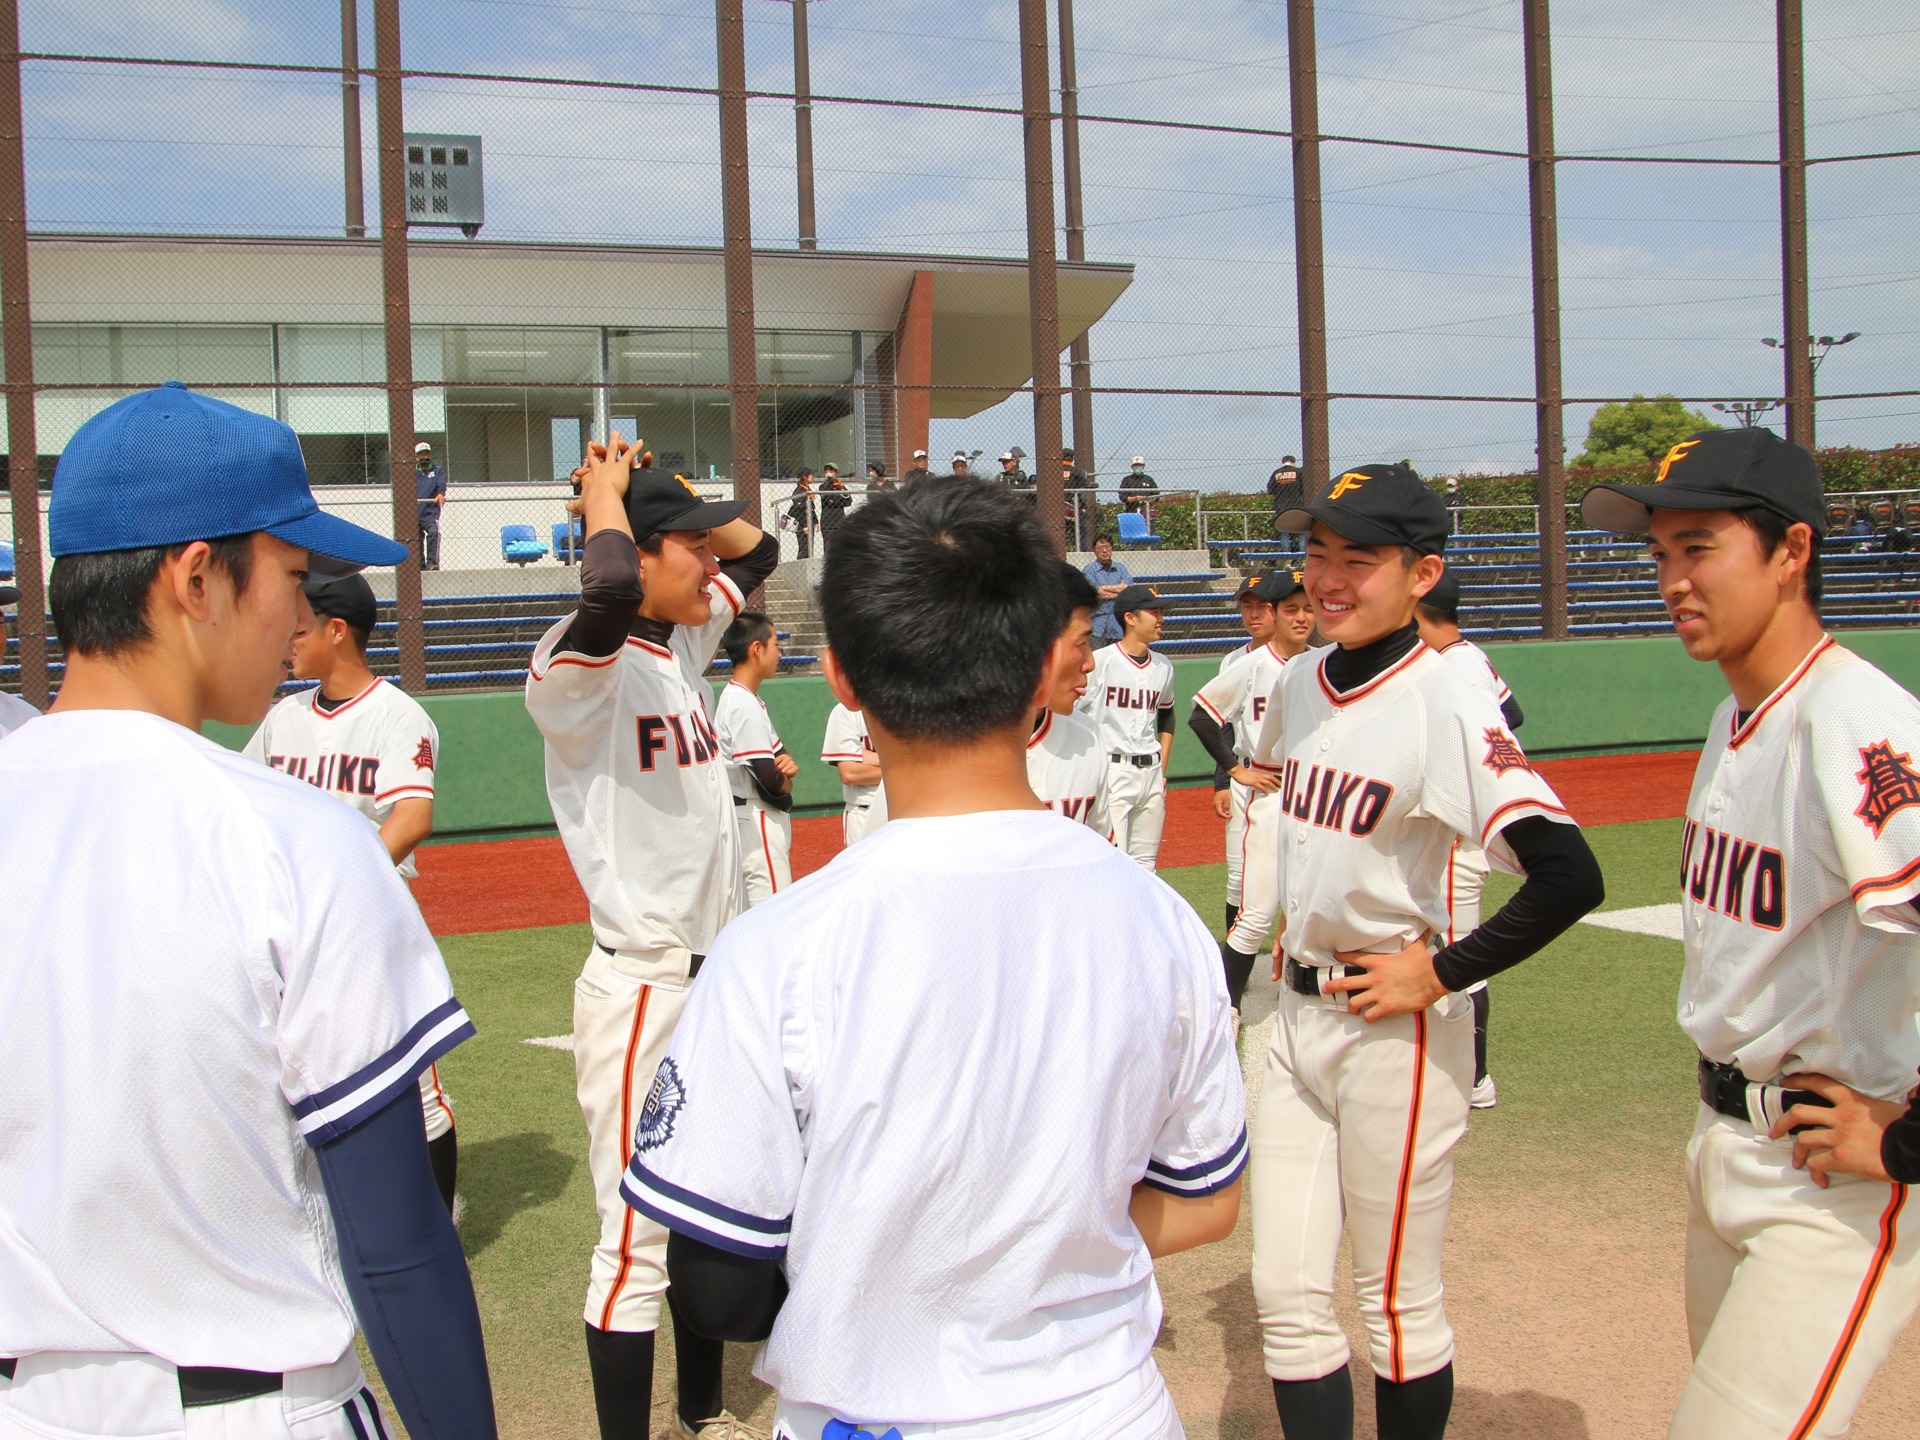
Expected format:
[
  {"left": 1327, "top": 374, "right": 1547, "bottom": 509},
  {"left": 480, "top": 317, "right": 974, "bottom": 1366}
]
[{"left": 526, "top": 574, "right": 743, "bottom": 954}]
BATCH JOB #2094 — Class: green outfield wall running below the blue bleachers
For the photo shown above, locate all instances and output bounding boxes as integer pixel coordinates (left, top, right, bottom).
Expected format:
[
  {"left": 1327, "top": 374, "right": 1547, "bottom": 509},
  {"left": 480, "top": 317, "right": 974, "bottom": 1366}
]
[{"left": 207, "top": 630, "right": 1920, "bottom": 839}]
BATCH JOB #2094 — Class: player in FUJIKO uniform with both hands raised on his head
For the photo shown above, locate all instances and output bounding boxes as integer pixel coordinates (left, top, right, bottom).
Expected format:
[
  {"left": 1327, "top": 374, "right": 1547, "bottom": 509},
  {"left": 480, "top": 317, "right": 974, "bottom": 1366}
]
[{"left": 526, "top": 434, "right": 780, "bottom": 1440}]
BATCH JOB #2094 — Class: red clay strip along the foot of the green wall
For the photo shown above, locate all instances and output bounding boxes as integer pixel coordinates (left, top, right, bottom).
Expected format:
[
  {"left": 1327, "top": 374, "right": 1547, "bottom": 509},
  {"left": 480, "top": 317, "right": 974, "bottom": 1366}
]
[{"left": 413, "top": 751, "right": 1699, "bottom": 935}]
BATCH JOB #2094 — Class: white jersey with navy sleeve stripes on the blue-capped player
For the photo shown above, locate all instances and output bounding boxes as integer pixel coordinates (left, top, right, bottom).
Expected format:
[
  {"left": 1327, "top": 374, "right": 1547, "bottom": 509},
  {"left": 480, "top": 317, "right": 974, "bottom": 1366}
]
[{"left": 0, "top": 710, "right": 472, "bottom": 1371}]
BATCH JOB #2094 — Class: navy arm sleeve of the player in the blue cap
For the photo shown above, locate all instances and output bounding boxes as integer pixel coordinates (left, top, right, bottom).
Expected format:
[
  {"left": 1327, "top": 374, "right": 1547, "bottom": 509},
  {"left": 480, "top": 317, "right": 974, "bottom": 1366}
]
[{"left": 313, "top": 1085, "right": 499, "bottom": 1440}]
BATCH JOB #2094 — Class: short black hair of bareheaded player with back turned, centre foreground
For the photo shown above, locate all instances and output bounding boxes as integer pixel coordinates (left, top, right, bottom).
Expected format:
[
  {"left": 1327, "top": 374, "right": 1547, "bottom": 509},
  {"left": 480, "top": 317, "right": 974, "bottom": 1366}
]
[{"left": 820, "top": 478, "right": 1062, "bottom": 743}]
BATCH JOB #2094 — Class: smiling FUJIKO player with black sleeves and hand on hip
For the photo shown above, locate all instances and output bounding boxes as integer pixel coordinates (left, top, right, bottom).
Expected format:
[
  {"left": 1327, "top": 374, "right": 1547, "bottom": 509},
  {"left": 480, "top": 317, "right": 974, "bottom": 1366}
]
[{"left": 1252, "top": 465, "right": 1601, "bottom": 1440}]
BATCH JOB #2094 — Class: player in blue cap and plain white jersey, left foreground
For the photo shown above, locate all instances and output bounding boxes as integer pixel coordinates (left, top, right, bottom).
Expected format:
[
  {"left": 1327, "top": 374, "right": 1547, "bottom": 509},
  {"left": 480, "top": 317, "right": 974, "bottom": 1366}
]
[{"left": 0, "top": 384, "right": 495, "bottom": 1440}]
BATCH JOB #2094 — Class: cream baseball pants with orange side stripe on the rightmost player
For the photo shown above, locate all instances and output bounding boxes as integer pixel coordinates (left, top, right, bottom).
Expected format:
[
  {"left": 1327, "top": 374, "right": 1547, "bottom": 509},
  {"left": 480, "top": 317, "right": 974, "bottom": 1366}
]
[{"left": 1668, "top": 1106, "right": 1920, "bottom": 1440}]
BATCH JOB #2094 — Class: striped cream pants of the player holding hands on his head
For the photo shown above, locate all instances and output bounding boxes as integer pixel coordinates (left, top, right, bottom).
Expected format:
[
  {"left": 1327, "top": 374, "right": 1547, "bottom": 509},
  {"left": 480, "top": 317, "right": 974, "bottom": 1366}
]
[{"left": 574, "top": 945, "right": 693, "bottom": 1331}]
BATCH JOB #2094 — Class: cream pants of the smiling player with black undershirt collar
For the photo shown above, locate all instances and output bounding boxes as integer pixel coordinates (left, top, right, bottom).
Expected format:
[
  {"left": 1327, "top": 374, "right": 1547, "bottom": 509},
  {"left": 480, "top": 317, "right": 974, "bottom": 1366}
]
[{"left": 1248, "top": 989, "right": 1473, "bottom": 1382}]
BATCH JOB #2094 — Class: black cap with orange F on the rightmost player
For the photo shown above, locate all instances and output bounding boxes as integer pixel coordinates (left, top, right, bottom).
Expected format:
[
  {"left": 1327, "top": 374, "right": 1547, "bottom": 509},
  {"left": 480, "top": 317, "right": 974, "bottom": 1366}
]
[{"left": 1580, "top": 426, "right": 1826, "bottom": 536}]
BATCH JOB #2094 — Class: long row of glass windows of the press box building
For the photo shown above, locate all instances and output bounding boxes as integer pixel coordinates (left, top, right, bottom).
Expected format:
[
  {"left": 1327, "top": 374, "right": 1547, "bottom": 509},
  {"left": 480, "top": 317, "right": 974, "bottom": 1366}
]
[{"left": 11, "top": 324, "right": 893, "bottom": 486}]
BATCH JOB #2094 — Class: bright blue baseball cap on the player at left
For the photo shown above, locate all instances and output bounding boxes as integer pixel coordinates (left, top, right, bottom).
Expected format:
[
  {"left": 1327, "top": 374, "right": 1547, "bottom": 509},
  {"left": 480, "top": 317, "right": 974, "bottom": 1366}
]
[{"left": 48, "top": 380, "right": 407, "bottom": 574}]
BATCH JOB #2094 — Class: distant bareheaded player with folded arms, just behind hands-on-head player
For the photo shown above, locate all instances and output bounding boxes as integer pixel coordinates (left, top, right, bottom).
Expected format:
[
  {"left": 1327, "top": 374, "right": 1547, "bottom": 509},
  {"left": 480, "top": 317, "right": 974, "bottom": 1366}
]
[{"left": 714, "top": 611, "right": 801, "bottom": 906}]
